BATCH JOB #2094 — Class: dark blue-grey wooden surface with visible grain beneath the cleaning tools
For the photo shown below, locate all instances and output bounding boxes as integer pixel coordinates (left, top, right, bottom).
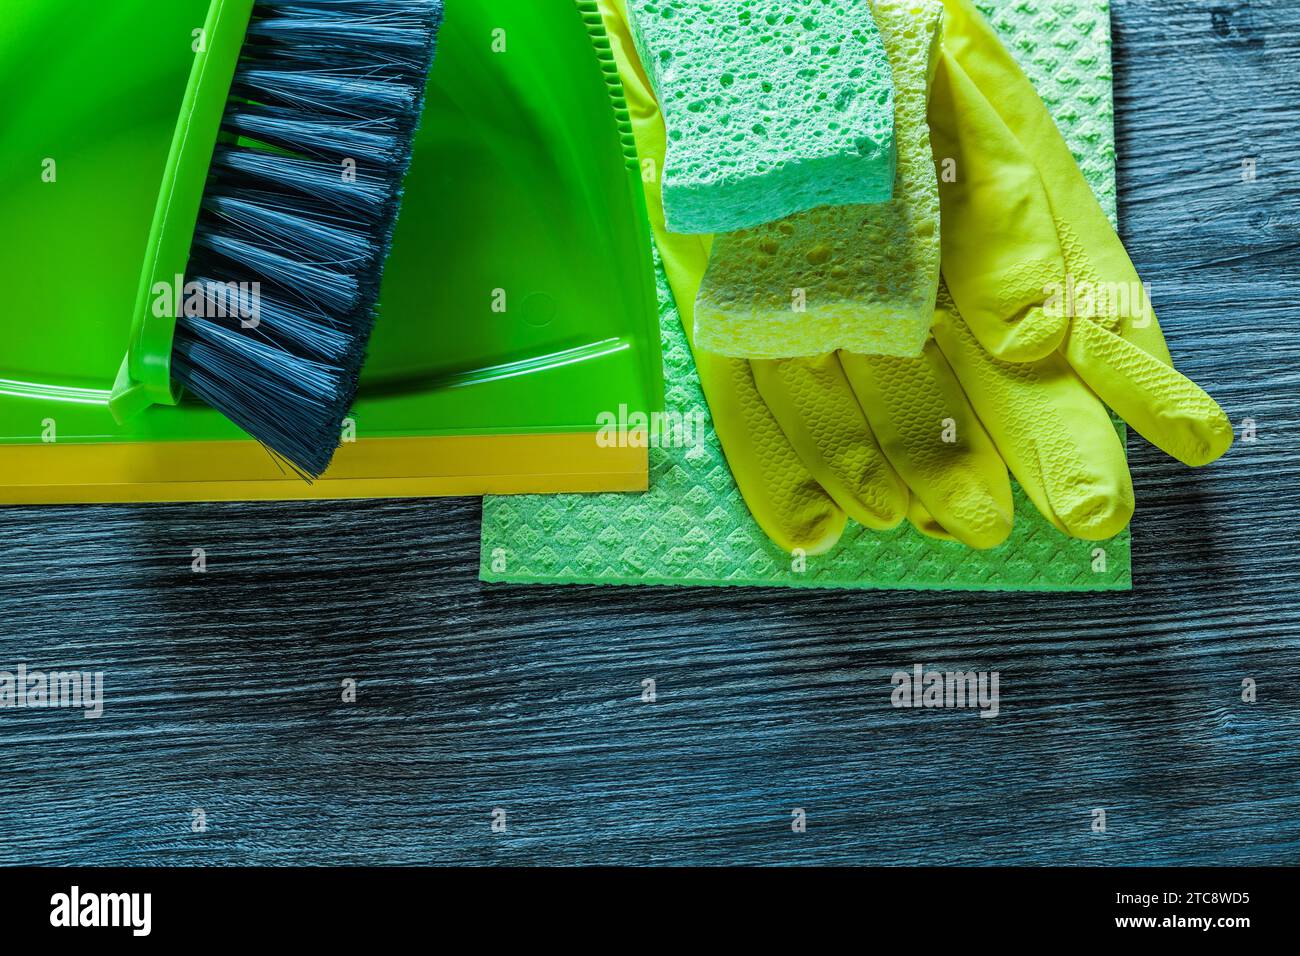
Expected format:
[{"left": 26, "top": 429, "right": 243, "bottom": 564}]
[{"left": 0, "top": 0, "right": 1300, "bottom": 864}]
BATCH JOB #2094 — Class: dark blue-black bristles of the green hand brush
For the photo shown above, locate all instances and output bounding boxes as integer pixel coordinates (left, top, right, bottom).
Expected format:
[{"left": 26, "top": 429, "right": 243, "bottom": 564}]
[{"left": 172, "top": 0, "right": 442, "bottom": 477}]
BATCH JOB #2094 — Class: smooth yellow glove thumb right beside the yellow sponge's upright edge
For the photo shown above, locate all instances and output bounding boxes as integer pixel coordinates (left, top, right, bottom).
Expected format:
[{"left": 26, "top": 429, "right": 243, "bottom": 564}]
[{"left": 930, "top": 52, "right": 1067, "bottom": 362}]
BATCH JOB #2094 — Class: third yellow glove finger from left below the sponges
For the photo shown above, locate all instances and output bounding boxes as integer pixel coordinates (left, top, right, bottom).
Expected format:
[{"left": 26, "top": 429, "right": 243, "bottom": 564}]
[{"left": 840, "top": 339, "right": 1014, "bottom": 549}]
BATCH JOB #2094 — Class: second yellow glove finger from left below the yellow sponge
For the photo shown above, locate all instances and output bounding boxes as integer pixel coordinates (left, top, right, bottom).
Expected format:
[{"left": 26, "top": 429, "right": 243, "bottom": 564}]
[{"left": 750, "top": 352, "right": 907, "bottom": 531}]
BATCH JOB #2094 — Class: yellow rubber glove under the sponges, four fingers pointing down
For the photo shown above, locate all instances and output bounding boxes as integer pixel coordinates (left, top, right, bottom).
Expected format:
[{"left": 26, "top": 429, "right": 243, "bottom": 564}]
[{"left": 601, "top": 0, "right": 1190, "bottom": 554}]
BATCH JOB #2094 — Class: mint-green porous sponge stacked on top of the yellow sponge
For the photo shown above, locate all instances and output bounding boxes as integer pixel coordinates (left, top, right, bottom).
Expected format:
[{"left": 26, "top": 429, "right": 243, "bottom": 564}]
[{"left": 627, "top": 0, "right": 894, "bottom": 234}]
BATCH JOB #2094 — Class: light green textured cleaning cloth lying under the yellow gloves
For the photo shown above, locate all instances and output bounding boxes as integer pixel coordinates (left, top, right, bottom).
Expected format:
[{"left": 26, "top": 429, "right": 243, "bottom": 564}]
[{"left": 481, "top": 0, "right": 1131, "bottom": 591}]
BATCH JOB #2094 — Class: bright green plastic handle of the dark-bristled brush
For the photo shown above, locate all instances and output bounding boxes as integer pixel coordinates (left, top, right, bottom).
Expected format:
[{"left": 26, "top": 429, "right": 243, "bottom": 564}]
[{"left": 108, "top": 0, "right": 255, "bottom": 423}]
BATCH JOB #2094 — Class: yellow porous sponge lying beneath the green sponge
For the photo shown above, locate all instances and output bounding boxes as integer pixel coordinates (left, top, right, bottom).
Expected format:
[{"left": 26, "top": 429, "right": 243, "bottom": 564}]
[{"left": 696, "top": 0, "right": 944, "bottom": 359}]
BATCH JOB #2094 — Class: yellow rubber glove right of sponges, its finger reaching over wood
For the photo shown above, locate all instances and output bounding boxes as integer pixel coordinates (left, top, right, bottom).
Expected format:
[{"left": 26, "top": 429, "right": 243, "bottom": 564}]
[{"left": 930, "top": 0, "right": 1232, "bottom": 468}]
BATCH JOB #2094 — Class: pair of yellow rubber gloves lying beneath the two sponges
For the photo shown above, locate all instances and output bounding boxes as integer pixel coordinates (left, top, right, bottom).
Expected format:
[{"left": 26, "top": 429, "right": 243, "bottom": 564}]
[{"left": 599, "top": 0, "right": 1232, "bottom": 554}]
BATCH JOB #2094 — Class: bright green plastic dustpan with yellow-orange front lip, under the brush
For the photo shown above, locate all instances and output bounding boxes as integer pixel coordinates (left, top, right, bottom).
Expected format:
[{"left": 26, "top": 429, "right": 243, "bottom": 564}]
[{"left": 0, "top": 0, "right": 663, "bottom": 502}]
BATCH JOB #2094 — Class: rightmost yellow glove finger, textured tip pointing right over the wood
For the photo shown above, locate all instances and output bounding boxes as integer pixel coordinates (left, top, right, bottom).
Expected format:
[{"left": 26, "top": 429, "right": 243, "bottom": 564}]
[{"left": 1066, "top": 320, "right": 1232, "bottom": 467}]
